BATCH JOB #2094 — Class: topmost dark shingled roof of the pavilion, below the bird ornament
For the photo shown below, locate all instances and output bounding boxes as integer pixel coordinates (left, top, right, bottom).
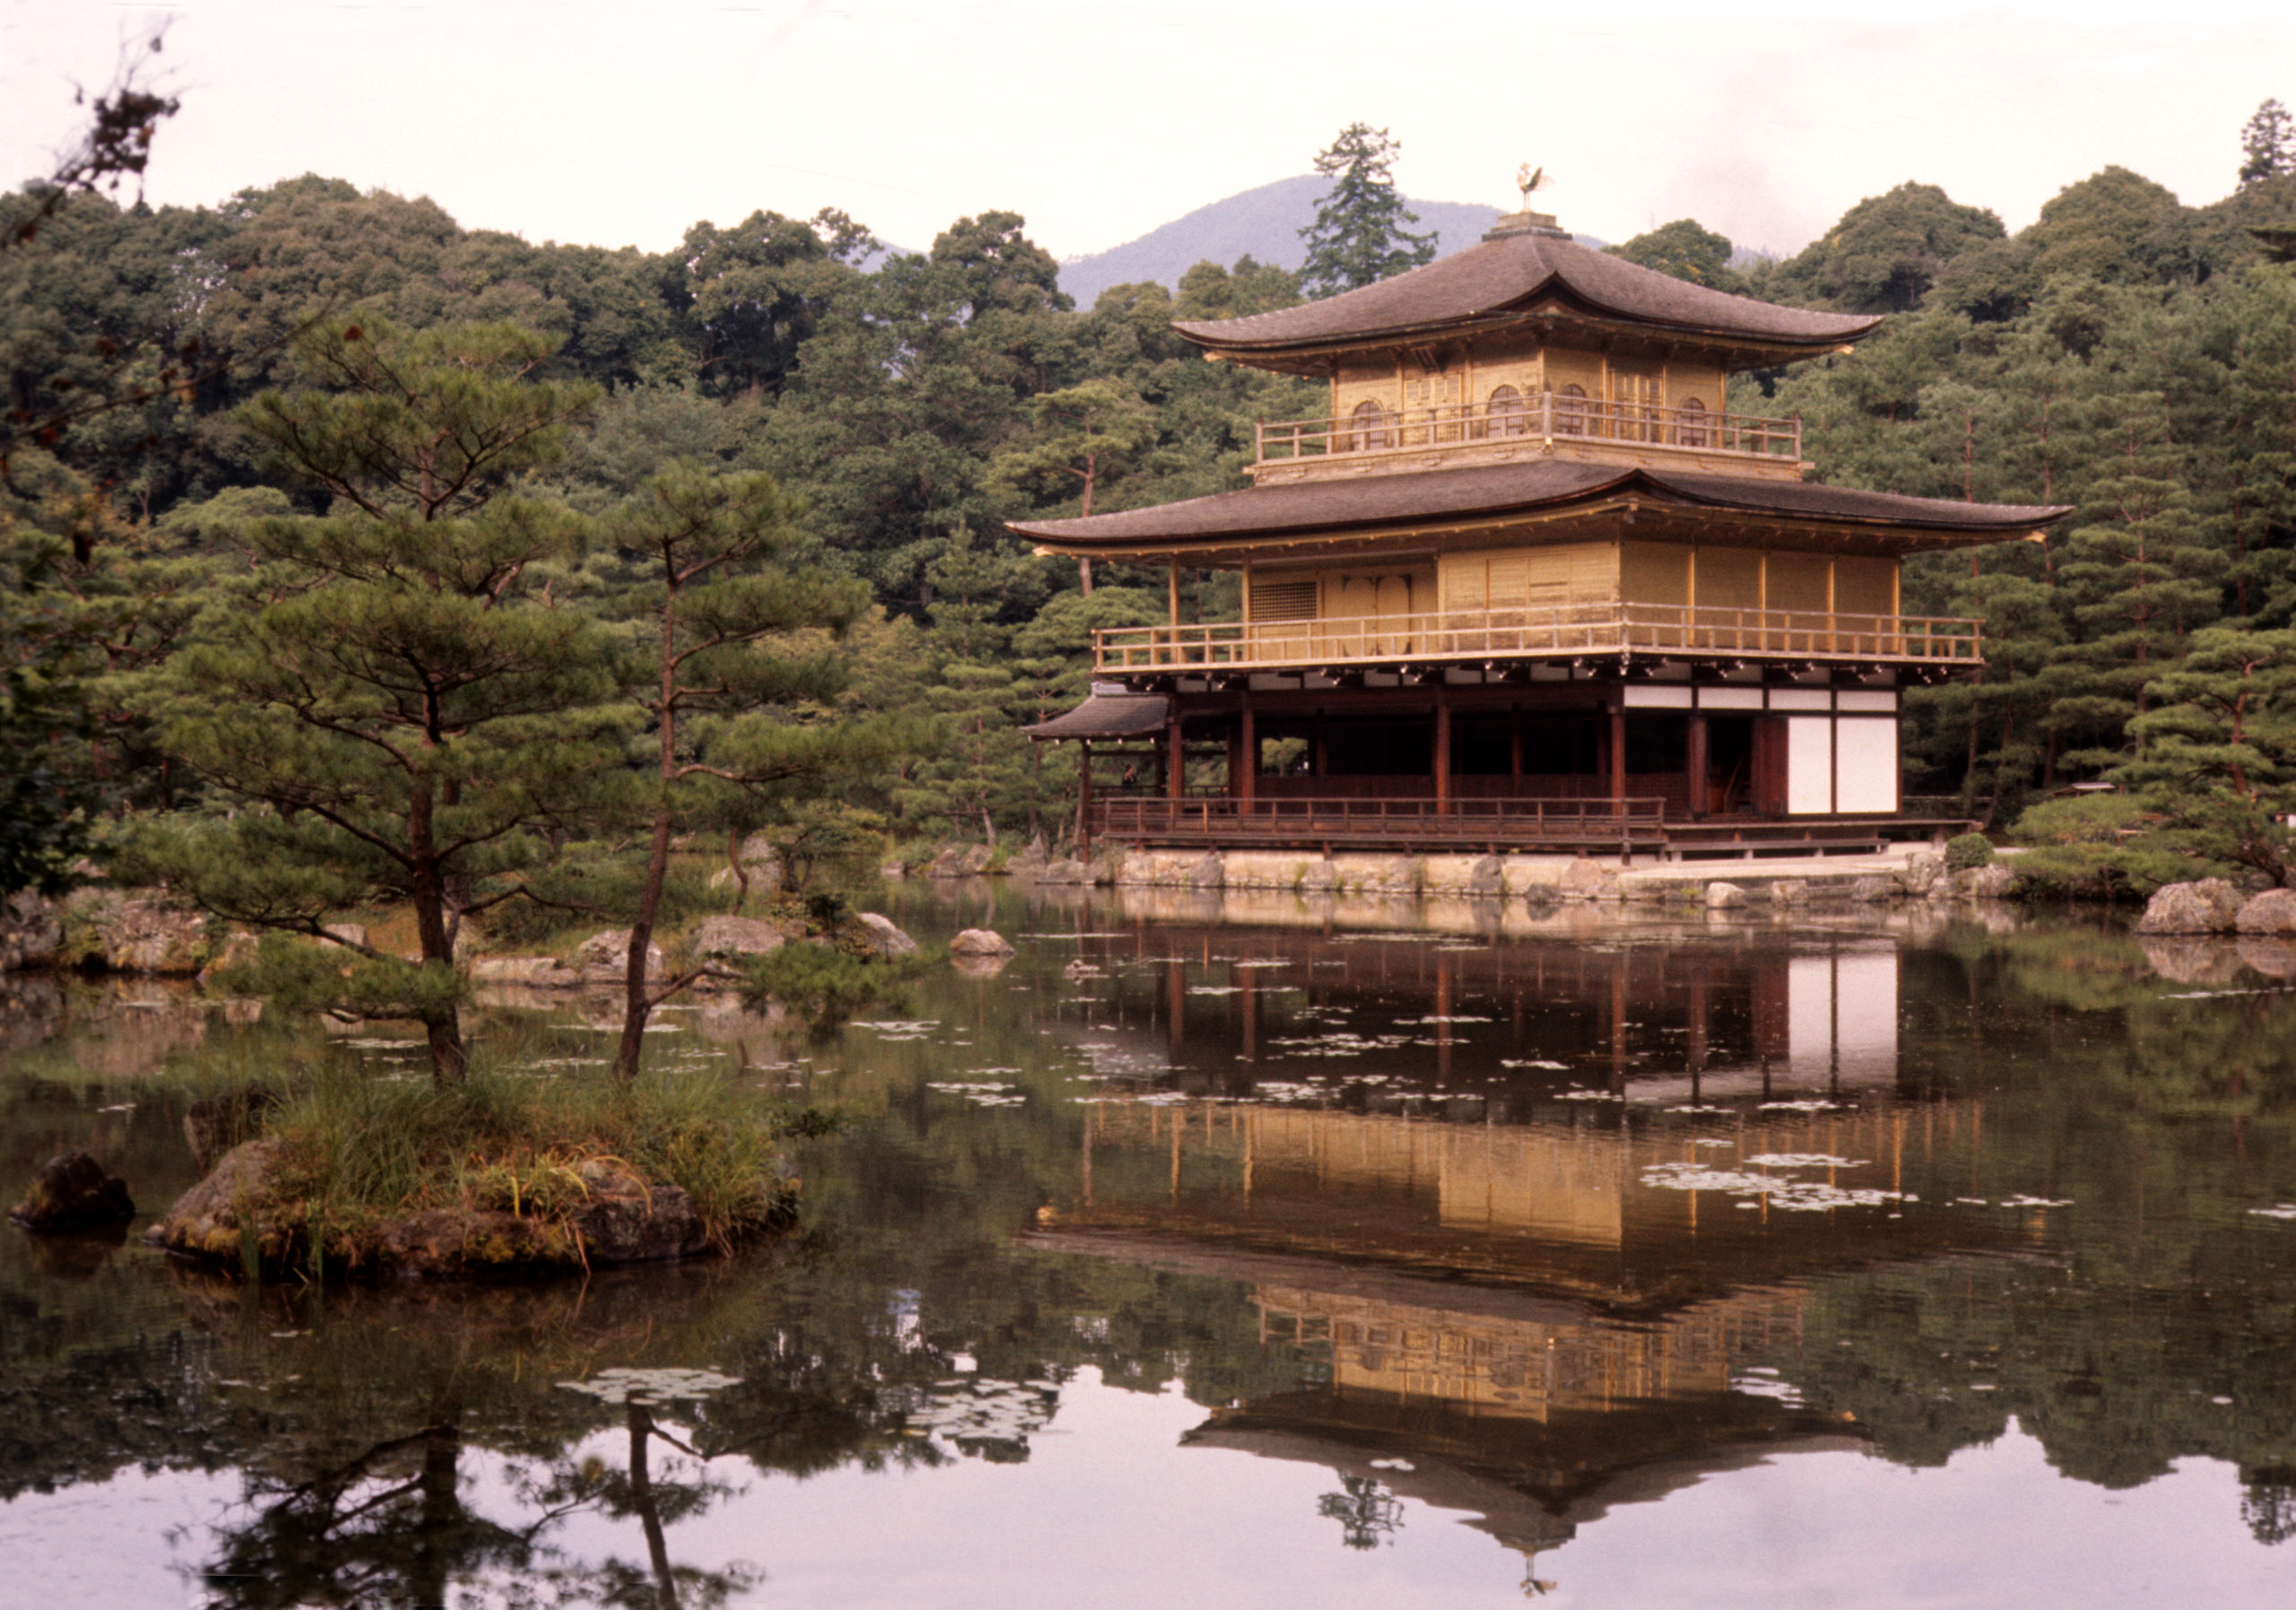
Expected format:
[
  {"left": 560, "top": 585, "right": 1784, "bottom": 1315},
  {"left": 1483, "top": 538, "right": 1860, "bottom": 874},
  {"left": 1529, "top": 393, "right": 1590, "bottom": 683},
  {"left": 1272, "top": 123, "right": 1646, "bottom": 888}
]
[{"left": 1173, "top": 234, "right": 1881, "bottom": 361}]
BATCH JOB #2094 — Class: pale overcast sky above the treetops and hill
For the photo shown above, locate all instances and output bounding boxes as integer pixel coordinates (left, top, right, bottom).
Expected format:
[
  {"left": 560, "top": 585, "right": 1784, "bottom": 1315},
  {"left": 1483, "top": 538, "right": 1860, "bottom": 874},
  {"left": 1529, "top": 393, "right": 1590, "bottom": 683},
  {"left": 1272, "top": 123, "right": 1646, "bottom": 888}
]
[{"left": 0, "top": 0, "right": 2296, "bottom": 257}]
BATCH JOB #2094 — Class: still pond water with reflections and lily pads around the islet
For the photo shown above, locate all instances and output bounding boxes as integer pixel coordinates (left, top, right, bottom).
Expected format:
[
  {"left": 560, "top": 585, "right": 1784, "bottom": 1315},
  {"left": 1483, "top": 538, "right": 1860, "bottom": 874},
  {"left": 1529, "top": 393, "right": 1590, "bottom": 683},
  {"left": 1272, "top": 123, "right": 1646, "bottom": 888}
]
[{"left": 0, "top": 884, "right": 2296, "bottom": 1610}]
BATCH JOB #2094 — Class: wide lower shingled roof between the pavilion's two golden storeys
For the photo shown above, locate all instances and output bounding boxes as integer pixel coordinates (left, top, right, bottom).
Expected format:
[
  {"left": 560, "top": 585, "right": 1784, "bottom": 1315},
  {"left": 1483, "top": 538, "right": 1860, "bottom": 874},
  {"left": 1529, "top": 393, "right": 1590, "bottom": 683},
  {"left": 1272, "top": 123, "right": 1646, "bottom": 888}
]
[{"left": 1013, "top": 459, "right": 2074, "bottom": 549}]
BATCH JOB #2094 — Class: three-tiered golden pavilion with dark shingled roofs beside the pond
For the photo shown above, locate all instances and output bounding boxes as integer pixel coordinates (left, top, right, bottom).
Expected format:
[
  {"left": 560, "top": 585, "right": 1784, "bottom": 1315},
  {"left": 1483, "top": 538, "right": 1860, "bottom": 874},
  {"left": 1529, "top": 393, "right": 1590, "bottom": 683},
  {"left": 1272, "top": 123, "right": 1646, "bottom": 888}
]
[{"left": 1013, "top": 196, "right": 2071, "bottom": 855}]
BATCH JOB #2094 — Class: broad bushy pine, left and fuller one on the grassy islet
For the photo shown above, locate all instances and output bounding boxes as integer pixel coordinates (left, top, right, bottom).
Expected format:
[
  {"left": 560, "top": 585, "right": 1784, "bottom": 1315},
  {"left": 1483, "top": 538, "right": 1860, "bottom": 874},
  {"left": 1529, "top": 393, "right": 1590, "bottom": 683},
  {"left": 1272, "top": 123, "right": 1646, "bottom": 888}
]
[{"left": 147, "top": 321, "right": 622, "bottom": 1084}]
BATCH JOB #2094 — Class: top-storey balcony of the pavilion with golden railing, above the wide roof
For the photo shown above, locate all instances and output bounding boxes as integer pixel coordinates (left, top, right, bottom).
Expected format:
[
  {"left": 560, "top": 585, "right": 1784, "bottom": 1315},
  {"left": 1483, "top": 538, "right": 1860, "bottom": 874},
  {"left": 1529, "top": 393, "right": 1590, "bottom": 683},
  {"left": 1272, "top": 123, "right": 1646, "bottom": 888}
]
[{"left": 1251, "top": 386, "right": 1807, "bottom": 483}]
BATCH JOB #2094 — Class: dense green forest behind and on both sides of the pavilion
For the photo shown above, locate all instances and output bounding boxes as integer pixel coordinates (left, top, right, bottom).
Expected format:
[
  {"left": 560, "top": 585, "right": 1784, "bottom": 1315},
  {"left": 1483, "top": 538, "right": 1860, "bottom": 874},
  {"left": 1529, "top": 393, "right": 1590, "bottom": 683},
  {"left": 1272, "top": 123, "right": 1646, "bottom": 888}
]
[{"left": 13, "top": 103, "right": 2296, "bottom": 886}]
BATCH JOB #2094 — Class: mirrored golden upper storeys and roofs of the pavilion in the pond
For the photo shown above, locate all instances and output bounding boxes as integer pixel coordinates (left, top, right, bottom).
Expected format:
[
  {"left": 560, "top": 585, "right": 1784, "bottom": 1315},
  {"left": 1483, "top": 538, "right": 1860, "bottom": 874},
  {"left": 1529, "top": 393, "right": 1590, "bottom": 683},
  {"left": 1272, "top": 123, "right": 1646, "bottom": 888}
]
[{"left": 1024, "top": 1079, "right": 2002, "bottom": 1576}]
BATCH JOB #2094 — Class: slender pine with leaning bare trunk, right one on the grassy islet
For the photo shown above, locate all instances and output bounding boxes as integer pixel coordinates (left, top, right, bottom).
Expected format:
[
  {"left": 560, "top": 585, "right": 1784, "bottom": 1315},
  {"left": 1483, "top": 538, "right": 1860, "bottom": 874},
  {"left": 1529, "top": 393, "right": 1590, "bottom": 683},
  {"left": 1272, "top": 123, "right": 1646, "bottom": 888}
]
[{"left": 592, "top": 462, "right": 876, "bottom": 1082}]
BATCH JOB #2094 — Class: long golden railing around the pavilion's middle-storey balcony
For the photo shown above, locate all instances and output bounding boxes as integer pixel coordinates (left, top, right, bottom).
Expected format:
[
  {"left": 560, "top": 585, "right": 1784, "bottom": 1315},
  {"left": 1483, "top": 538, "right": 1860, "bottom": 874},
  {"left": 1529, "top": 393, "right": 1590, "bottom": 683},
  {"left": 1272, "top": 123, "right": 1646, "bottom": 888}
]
[{"left": 1093, "top": 604, "right": 1984, "bottom": 673}]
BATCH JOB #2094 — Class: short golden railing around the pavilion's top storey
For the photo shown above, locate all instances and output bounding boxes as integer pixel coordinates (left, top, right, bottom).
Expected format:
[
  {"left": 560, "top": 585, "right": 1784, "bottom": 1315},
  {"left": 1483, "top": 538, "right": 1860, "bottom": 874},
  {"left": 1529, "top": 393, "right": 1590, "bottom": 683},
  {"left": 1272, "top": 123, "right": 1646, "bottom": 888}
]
[{"left": 1258, "top": 390, "right": 1803, "bottom": 464}]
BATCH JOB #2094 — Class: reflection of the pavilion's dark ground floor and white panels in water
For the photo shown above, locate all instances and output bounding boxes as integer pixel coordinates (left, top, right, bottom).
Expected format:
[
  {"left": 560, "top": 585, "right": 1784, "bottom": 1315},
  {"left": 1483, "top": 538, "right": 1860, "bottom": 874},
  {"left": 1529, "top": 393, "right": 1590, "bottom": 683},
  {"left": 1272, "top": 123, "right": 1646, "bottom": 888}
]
[{"left": 1051, "top": 926, "right": 1901, "bottom": 1102}]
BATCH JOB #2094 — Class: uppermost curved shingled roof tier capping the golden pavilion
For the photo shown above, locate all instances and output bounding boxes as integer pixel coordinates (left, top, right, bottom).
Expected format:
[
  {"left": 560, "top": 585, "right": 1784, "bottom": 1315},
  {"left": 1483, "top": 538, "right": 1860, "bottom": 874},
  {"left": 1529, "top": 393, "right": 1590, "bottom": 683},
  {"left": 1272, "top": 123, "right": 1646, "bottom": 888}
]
[{"left": 1173, "top": 232, "right": 1881, "bottom": 374}]
